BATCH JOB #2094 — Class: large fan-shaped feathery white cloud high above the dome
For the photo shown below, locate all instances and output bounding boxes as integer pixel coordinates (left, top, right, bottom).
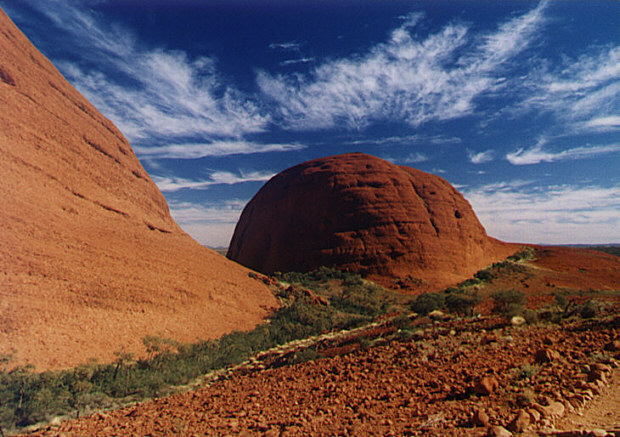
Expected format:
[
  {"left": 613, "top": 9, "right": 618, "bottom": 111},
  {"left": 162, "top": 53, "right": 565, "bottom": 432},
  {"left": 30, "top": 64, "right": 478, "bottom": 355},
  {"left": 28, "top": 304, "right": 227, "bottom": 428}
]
[{"left": 257, "top": 4, "right": 544, "bottom": 130}]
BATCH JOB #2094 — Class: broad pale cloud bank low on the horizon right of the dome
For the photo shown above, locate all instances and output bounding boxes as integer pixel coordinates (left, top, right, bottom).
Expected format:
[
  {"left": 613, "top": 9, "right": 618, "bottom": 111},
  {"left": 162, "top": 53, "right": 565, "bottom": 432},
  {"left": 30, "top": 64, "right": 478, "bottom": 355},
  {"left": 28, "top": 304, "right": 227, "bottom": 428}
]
[{"left": 463, "top": 184, "right": 620, "bottom": 244}]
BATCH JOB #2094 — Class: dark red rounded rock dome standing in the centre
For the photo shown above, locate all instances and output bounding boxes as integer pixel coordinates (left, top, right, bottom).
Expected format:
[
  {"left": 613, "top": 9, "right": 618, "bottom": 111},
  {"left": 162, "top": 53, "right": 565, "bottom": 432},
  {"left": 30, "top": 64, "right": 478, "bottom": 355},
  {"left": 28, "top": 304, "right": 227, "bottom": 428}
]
[{"left": 227, "top": 153, "right": 515, "bottom": 286}]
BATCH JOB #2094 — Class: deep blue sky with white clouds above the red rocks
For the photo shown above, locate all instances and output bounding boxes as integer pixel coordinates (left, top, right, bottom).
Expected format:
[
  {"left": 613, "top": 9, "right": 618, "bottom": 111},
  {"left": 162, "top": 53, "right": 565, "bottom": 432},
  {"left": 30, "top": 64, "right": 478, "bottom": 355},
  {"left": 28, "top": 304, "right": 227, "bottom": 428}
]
[{"left": 0, "top": 0, "right": 620, "bottom": 247}]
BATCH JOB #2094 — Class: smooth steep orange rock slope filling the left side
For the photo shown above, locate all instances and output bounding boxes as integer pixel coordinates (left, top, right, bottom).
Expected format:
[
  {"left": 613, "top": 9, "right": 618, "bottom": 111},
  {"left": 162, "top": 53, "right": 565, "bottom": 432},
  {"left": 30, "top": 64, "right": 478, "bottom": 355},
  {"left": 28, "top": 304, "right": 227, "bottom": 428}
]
[{"left": 0, "top": 10, "right": 276, "bottom": 370}]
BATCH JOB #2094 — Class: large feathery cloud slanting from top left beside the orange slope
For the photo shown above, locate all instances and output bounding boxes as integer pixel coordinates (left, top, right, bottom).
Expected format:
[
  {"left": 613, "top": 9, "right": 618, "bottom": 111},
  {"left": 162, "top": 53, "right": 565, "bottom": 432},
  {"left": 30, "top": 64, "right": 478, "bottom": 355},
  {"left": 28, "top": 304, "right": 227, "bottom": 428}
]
[{"left": 19, "top": 0, "right": 270, "bottom": 153}]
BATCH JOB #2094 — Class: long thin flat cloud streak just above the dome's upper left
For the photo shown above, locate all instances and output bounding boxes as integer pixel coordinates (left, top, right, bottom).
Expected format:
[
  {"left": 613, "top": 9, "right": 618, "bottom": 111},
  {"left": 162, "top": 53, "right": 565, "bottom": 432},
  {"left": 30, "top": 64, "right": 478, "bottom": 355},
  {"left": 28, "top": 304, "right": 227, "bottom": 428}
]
[{"left": 134, "top": 141, "right": 306, "bottom": 159}]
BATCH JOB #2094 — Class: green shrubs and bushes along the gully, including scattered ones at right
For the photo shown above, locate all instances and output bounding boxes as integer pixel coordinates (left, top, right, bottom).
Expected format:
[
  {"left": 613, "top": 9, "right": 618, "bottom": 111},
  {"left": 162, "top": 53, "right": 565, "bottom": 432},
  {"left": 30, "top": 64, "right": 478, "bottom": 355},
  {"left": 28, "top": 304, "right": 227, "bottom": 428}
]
[{"left": 0, "top": 249, "right": 616, "bottom": 432}]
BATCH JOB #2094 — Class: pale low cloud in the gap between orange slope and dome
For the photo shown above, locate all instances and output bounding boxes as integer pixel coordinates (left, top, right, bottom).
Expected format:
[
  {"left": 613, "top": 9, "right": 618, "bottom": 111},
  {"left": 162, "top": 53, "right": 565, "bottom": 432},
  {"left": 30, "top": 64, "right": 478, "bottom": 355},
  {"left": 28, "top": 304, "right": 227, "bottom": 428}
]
[{"left": 170, "top": 199, "right": 247, "bottom": 247}]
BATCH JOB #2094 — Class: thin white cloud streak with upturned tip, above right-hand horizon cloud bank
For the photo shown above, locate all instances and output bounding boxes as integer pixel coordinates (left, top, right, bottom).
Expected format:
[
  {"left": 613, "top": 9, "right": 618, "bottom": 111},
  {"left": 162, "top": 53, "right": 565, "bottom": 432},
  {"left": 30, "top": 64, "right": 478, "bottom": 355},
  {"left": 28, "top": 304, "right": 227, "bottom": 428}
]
[{"left": 506, "top": 139, "right": 620, "bottom": 165}]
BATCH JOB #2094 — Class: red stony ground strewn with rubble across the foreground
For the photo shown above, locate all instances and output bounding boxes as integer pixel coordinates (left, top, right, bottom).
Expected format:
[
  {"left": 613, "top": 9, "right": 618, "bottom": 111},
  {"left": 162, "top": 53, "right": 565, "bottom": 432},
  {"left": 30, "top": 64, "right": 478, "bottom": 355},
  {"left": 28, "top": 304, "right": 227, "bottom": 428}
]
[{"left": 21, "top": 317, "right": 620, "bottom": 436}]
